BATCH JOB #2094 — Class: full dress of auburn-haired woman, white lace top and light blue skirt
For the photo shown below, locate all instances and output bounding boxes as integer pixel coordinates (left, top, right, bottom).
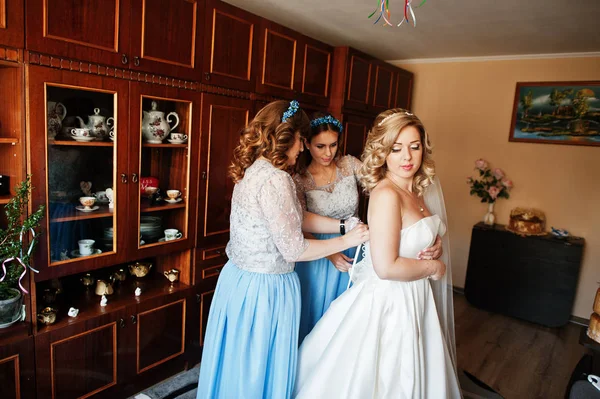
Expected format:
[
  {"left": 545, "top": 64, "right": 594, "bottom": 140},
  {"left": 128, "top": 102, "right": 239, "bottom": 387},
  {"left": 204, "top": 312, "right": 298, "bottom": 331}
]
[{"left": 197, "top": 160, "right": 308, "bottom": 399}]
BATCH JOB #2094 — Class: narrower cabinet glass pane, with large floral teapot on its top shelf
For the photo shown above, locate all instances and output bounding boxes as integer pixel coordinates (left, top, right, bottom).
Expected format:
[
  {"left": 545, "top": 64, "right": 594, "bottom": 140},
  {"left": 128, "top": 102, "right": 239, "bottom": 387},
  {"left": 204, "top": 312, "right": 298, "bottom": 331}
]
[{"left": 139, "top": 96, "right": 190, "bottom": 246}]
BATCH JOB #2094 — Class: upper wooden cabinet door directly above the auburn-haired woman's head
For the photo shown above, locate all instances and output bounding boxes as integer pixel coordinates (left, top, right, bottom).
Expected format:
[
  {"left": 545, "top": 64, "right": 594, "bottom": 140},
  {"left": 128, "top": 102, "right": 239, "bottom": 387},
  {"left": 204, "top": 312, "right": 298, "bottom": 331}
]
[{"left": 256, "top": 19, "right": 304, "bottom": 99}]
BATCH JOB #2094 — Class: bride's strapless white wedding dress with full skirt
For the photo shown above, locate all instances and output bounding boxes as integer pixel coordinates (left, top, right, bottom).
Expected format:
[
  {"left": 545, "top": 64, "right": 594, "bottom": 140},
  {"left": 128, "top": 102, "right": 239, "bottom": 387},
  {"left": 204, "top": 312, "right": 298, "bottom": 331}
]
[{"left": 294, "top": 215, "right": 461, "bottom": 399}]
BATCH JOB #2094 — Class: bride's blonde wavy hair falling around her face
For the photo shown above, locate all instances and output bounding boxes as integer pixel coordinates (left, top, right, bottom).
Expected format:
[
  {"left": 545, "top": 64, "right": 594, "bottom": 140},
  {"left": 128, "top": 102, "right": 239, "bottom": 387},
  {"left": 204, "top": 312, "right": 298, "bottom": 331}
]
[{"left": 359, "top": 108, "right": 435, "bottom": 196}]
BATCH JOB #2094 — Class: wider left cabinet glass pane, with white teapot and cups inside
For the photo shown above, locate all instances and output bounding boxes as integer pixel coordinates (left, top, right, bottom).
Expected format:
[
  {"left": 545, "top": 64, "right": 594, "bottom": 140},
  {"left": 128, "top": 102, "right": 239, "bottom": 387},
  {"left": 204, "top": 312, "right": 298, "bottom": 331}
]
[{"left": 46, "top": 85, "right": 117, "bottom": 263}]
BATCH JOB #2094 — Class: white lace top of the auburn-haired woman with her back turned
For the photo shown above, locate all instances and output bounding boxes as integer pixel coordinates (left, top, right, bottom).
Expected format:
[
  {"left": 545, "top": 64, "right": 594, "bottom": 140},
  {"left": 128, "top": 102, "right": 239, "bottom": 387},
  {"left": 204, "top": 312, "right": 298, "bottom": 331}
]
[{"left": 226, "top": 160, "right": 309, "bottom": 274}]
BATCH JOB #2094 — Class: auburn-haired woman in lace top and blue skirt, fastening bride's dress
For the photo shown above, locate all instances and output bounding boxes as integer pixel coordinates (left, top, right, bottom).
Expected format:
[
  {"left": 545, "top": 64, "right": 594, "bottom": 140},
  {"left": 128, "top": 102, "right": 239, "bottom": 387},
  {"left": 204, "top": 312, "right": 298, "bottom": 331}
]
[{"left": 197, "top": 101, "right": 368, "bottom": 399}]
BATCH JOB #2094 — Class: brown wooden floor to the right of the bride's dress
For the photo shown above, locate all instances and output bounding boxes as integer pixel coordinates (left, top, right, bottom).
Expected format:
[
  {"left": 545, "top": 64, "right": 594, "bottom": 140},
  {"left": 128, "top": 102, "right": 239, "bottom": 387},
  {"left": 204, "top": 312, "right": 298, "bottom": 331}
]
[{"left": 454, "top": 294, "right": 585, "bottom": 399}]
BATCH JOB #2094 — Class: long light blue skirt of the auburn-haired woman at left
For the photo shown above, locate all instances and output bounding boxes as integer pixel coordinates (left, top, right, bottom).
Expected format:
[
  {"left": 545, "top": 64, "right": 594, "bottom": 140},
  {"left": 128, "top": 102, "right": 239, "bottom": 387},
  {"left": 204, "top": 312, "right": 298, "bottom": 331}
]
[{"left": 197, "top": 262, "right": 300, "bottom": 399}]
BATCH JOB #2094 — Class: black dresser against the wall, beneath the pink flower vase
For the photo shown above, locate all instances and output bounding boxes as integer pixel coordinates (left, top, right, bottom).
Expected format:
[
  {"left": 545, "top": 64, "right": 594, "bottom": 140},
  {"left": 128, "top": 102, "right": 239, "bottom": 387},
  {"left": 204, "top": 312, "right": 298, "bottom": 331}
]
[{"left": 465, "top": 223, "right": 584, "bottom": 327}]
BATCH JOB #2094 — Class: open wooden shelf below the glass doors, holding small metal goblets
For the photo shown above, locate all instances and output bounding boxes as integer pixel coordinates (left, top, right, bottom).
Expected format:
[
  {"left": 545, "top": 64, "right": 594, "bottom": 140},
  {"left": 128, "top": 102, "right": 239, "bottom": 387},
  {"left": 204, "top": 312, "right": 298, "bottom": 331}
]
[{"left": 38, "top": 273, "right": 190, "bottom": 334}]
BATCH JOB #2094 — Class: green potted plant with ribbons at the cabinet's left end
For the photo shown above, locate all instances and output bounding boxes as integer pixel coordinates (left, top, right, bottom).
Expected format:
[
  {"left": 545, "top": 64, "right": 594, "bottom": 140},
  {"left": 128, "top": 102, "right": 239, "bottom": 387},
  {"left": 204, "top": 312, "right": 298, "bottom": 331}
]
[{"left": 0, "top": 175, "right": 44, "bottom": 328}]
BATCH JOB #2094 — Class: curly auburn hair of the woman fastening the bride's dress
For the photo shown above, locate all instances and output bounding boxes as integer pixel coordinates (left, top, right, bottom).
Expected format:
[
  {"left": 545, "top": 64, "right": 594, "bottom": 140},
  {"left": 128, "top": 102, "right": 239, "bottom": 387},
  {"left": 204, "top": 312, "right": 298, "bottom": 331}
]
[{"left": 229, "top": 100, "right": 310, "bottom": 183}]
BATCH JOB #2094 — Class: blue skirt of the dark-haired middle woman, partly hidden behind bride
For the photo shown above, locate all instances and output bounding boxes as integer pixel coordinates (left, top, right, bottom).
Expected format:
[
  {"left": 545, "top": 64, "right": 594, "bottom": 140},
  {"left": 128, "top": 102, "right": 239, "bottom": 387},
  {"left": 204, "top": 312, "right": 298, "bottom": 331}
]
[{"left": 296, "top": 234, "right": 356, "bottom": 345}]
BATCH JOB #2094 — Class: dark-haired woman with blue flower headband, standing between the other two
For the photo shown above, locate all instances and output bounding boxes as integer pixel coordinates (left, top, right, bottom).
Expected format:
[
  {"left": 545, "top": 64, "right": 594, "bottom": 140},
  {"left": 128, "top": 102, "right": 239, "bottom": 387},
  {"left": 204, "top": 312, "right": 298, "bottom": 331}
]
[{"left": 294, "top": 114, "right": 362, "bottom": 343}]
